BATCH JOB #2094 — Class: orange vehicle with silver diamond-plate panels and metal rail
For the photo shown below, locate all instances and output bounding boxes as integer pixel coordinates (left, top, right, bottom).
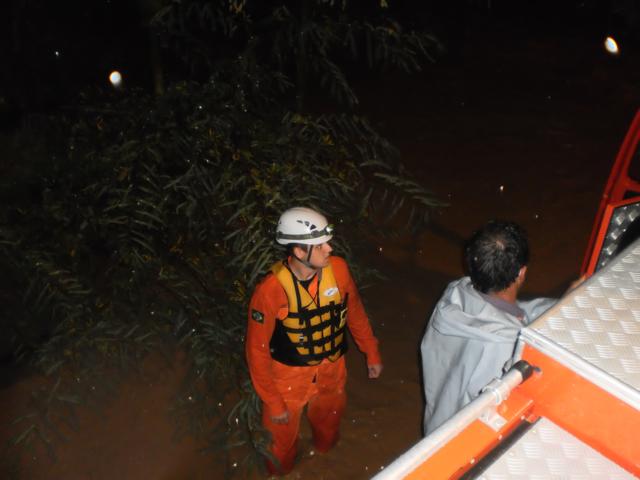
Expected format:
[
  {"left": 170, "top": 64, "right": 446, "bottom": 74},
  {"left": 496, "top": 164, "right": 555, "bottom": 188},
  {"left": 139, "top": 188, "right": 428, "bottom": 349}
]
[{"left": 374, "top": 110, "right": 640, "bottom": 480}]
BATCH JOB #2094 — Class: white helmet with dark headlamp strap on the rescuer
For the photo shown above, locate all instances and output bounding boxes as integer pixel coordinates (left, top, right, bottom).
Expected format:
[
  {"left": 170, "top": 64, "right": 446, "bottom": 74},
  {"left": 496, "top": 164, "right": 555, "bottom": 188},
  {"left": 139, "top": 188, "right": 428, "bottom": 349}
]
[{"left": 276, "top": 207, "right": 333, "bottom": 245}]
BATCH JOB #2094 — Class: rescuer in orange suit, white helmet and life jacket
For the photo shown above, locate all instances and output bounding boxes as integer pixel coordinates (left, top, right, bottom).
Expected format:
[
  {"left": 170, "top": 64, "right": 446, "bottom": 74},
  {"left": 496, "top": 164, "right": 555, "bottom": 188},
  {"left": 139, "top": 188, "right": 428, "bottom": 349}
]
[{"left": 246, "top": 207, "right": 382, "bottom": 475}]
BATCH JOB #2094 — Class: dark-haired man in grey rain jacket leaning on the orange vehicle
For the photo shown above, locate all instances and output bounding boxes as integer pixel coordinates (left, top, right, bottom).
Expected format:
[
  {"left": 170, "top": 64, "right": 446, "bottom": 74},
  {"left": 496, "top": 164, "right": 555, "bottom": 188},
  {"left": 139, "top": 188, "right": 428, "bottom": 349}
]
[{"left": 420, "top": 221, "right": 555, "bottom": 435}]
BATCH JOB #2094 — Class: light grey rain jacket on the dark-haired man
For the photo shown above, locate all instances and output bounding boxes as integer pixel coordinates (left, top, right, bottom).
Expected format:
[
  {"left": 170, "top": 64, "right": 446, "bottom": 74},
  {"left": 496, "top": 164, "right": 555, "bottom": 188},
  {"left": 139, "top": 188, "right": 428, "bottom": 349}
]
[{"left": 420, "top": 277, "right": 556, "bottom": 435}]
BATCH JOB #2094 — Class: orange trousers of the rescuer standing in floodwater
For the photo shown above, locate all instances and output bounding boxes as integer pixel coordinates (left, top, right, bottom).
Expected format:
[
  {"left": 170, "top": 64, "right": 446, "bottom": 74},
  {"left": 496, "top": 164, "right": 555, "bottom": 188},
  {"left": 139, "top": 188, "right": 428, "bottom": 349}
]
[{"left": 262, "top": 357, "right": 347, "bottom": 474}]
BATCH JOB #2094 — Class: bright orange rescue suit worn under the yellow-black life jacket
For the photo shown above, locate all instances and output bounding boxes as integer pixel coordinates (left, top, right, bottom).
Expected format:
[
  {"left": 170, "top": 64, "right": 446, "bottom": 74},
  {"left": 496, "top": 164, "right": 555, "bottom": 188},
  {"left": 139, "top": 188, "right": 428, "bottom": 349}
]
[{"left": 246, "top": 257, "right": 382, "bottom": 473}]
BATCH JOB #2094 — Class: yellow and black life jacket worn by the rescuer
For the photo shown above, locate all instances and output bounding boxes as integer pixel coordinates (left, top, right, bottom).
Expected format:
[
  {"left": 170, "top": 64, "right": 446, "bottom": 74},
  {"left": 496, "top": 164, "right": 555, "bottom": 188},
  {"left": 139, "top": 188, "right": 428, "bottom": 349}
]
[{"left": 269, "top": 262, "right": 349, "bottom": 366}]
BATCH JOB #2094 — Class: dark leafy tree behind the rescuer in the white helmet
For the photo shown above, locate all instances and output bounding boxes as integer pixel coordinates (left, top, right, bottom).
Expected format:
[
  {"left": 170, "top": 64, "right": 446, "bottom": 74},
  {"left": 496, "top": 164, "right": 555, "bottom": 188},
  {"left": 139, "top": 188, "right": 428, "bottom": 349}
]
[{"left": 0, "top": 1, "right": 438, "bottom": 472}]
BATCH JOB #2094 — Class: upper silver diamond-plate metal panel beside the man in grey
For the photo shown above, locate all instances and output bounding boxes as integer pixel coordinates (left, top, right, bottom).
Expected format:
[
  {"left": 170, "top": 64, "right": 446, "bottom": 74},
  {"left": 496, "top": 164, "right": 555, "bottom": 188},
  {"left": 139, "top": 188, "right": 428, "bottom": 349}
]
[{"left": 521, "top": 240, "right": 640, "bottom": 409}]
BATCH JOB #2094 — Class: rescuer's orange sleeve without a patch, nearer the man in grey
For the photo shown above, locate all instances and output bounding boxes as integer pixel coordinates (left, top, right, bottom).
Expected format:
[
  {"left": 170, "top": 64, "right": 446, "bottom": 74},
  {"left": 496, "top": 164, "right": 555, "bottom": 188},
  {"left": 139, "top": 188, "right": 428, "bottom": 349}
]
[{"left": 331, "top": 257, "right": 382, "bottom": 365}]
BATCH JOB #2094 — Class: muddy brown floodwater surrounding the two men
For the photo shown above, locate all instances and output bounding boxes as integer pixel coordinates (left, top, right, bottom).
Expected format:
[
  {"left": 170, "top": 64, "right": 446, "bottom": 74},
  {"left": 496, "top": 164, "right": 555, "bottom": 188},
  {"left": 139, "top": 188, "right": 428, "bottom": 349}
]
[{"left": 0, "top": 15, "right": 640, "bottom": 480}]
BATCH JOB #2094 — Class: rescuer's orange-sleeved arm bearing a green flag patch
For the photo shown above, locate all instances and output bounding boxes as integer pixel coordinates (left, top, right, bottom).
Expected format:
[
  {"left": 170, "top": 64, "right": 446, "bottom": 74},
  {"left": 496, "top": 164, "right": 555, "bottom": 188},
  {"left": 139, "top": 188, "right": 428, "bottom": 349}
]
[{"left": 245, "top": 278, "right": 287, "bottom": 416}]
